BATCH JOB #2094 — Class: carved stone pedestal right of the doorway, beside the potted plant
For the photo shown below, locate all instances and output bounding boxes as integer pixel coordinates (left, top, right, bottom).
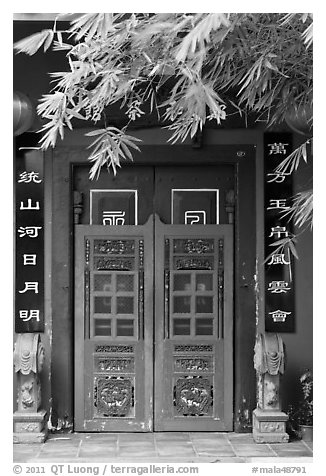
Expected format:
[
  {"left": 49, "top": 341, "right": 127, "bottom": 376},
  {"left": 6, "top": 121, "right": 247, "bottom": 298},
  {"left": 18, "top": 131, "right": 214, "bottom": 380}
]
[{"left": 253, "top": 334, "right": 289, "bottom": 443}]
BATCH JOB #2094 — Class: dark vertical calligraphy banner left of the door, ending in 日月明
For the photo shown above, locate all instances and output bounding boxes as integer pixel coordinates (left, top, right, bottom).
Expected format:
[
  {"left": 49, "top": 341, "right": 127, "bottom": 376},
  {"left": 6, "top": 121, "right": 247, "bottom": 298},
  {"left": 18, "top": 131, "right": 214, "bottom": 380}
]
[{"left": 15, "top": 149, "right": 44, "bottom": 333}]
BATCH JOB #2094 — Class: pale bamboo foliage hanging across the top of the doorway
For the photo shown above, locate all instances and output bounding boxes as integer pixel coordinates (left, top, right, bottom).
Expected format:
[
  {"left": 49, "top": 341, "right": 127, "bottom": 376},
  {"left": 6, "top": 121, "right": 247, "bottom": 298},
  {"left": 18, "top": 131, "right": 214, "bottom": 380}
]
[{"left": 15, "top": 13, "right": 312, "bottom": 182}]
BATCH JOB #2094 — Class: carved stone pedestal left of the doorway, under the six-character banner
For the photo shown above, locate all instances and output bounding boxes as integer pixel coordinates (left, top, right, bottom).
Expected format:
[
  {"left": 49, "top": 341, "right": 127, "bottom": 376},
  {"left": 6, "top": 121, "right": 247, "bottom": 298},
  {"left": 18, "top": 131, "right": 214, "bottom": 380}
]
[{"left": 14, "top": 333, "right": 47, "bottom": 443}]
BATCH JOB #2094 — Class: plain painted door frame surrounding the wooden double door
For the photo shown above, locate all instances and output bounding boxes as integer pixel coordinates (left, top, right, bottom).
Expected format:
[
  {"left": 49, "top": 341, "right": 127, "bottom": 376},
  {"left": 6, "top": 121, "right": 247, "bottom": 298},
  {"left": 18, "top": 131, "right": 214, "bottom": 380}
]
[{"left": 48, "top": 141, "right": 256, "bottom": 431}]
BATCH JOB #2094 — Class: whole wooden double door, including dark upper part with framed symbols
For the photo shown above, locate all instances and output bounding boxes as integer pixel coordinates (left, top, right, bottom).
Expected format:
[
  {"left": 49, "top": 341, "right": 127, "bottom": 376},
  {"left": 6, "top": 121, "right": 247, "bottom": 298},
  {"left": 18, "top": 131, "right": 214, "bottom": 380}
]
[{"left": 74, "top": 166, "right": 233, "bottom": 432}]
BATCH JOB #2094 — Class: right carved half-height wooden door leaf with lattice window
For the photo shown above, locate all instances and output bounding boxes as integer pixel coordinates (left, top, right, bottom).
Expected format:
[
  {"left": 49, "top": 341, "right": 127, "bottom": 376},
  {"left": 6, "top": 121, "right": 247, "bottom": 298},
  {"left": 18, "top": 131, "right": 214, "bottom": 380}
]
[{"left": 154, "top": 217, "right": 233, "bottom": 431}]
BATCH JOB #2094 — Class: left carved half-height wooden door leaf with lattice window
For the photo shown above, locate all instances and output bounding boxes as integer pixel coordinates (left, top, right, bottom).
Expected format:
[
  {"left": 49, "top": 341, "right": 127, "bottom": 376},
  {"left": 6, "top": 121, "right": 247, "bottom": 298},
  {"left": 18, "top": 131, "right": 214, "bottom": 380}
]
[{"left": 75, "top": 219, "right": 153, "bottom": 431}]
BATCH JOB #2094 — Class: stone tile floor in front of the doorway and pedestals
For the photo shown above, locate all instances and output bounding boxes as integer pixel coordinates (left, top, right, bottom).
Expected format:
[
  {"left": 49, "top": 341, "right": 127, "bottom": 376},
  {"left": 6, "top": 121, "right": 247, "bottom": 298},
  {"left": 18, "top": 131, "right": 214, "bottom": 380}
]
[{"left": 13, "top": 432, "right": 313, "bottom": 463}]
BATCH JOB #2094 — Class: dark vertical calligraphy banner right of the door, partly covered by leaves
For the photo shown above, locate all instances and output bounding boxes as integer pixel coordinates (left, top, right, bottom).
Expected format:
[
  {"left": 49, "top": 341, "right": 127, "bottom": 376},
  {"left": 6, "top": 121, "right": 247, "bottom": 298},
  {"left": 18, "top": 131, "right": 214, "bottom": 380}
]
[{"left": 264, "top": 132, "right": 295, "bottom": 332}]
